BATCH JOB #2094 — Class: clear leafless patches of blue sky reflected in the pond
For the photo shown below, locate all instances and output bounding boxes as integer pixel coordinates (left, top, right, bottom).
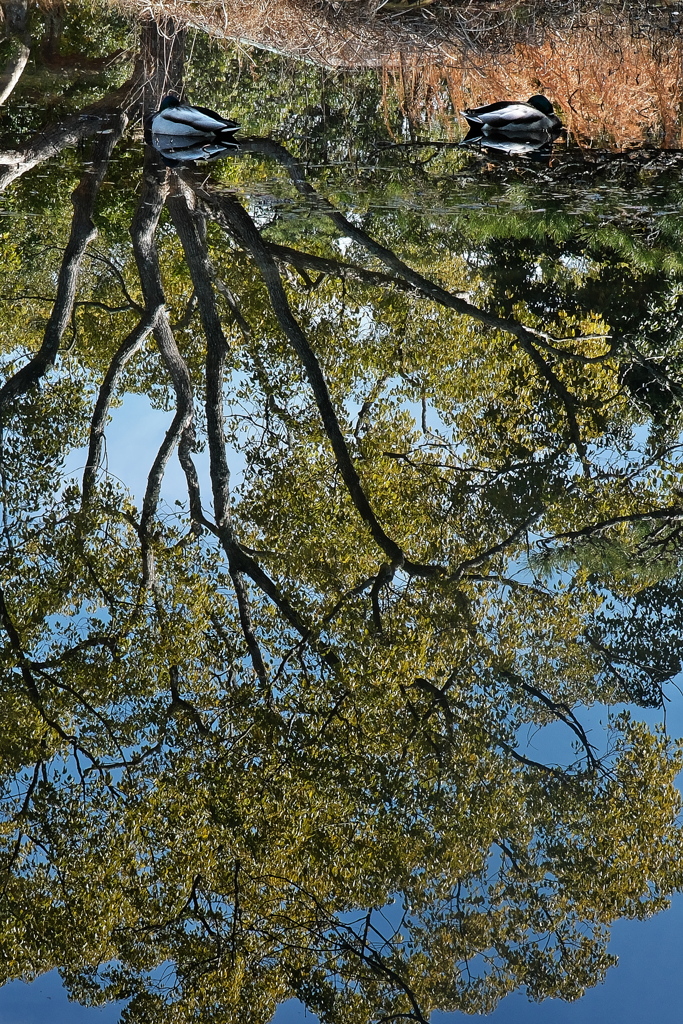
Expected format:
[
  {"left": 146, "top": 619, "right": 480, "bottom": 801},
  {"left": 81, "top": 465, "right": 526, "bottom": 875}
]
[{"left": 5, "top": 339, "right": 683, "bottom": 1024}]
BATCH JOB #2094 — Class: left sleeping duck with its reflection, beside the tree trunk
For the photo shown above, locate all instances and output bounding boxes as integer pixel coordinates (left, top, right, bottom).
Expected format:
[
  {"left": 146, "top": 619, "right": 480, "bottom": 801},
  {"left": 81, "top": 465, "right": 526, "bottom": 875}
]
[{"left": 144, "top": 93, "right": 240, "bottom": 163}]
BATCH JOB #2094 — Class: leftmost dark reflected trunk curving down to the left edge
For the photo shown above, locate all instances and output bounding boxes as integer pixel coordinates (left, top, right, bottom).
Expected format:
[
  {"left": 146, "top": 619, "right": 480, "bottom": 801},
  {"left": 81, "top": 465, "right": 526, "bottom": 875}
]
[{"left": 0, "top": 114, "right": 126, "bottom": 413}]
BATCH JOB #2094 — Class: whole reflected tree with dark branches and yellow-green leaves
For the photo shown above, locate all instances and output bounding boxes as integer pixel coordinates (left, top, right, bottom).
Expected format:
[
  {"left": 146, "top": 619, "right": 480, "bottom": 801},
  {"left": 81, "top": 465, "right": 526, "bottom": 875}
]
[{"left": 0, "top": 14, "right": 683, "bottom": 1021}]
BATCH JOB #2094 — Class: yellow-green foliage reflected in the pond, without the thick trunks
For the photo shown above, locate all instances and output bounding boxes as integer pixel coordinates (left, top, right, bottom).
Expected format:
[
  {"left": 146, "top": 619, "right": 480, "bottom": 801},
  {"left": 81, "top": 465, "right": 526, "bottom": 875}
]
[{"left": 0, "top": 9, "right": 683, "bottom": 1024}]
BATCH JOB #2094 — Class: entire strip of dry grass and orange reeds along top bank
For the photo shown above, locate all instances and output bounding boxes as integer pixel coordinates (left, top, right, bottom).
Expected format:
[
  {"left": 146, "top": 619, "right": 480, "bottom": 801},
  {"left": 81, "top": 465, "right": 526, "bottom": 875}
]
[{"left": 105, "top": 0, "right": 683, "bottom": 148}]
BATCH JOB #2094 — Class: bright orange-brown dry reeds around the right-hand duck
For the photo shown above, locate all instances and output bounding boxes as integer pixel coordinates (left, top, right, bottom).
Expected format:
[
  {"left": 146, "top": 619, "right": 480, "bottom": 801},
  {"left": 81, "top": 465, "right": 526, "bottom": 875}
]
[{"left": 385, "top": 7, "right": 683, "bottom": 150}]
